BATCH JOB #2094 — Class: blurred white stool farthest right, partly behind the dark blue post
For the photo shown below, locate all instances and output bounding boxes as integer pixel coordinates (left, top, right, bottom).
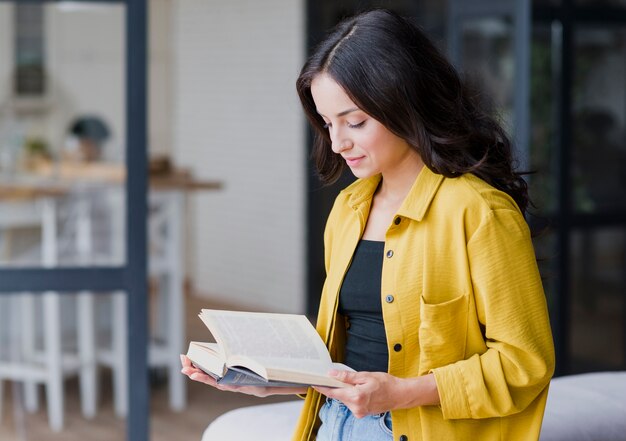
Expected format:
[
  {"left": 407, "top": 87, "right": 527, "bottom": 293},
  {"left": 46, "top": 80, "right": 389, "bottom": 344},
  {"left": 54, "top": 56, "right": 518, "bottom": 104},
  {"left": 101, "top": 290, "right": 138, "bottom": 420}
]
[{"left": 91, "top": 190, "right": 187, "bottom": 417}]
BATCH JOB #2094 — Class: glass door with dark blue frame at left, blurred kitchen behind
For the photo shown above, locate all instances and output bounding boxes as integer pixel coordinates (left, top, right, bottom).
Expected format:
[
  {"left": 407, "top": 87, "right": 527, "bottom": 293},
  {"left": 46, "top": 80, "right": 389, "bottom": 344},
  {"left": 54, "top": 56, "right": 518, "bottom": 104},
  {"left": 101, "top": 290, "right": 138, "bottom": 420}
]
[{"left": 0, "top": 0, "right": 149, "bottom": 441}]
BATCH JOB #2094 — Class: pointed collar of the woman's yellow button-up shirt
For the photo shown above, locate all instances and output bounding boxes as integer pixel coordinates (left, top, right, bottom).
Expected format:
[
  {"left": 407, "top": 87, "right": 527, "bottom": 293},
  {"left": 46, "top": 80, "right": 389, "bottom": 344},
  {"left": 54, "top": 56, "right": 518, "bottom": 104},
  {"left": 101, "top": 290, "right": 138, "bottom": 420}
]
[{"left": 344, "top": 166, "right": 444, "bottom": 221}]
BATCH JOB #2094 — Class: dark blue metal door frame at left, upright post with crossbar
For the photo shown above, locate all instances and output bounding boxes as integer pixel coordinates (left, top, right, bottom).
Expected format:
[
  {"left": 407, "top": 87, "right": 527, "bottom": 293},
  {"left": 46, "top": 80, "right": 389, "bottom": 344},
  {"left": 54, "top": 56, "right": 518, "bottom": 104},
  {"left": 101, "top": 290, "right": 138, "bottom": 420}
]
[{"left": 0, "top": 0, "right": 150, "bottom": 441}]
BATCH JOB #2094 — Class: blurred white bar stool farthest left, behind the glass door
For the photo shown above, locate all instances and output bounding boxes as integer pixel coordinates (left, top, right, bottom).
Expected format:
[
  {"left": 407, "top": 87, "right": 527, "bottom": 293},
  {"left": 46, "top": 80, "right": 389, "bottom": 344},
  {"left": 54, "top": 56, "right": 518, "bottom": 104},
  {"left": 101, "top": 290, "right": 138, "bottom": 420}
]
[{"left": 0, "top": 197, "right": 96, "bottom": 431}]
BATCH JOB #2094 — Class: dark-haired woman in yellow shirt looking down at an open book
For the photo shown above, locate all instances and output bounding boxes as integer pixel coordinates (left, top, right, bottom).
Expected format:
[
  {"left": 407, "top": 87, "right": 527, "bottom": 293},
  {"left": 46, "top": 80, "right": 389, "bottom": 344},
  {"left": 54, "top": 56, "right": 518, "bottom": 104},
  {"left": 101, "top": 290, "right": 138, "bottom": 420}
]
[{"left": 184, "top": 10, "right": 554, "bottom": 441}]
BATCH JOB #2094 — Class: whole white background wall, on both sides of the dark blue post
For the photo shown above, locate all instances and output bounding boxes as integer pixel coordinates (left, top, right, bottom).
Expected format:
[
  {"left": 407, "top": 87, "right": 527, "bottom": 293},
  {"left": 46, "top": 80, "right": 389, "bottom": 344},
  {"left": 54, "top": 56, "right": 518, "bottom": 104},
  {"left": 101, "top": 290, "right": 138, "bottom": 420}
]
[{"left": 0, "top": 0, "right": 306, "bottom": 312}]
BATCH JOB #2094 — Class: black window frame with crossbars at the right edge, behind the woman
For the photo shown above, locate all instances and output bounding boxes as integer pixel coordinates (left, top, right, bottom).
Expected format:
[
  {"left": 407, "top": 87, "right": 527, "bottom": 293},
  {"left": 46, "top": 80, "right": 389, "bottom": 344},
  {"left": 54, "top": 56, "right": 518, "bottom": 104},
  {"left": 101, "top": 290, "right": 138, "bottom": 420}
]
[{"left": 533, "top": 0, "right": 626, "bottom": 376}]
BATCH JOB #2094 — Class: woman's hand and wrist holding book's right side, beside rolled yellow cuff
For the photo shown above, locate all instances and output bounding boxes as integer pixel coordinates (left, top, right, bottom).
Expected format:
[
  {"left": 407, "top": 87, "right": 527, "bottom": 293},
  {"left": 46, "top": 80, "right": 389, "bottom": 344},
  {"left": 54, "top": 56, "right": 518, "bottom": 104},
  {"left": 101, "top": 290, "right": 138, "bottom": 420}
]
[{"left": 313, "top": 370, "right": 440, "bottom": 418}]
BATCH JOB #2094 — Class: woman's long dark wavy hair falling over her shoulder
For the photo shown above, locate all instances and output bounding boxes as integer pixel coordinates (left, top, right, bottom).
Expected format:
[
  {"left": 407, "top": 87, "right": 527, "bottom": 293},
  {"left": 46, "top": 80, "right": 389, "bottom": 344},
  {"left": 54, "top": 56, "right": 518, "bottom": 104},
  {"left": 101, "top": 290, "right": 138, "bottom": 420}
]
[{"left": 296, "top": 9, "right": 529, "bottom": 213}]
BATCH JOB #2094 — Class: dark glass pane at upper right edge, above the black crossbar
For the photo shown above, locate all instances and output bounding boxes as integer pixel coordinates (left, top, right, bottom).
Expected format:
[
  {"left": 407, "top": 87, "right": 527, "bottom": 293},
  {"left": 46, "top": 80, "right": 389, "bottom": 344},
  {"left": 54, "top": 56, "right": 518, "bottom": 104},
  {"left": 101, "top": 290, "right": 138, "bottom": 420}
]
[{"left": 572, "top": 27, "right": 626, "bottom": 212}]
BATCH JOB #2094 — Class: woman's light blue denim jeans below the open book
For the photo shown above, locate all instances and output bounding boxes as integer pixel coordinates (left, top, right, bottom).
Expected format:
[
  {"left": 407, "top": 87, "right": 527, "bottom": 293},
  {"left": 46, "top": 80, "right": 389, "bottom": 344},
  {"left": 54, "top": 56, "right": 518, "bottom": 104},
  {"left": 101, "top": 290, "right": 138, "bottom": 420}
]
[{"left": 316, "top": 398, "right": 393, "bottom": 441}]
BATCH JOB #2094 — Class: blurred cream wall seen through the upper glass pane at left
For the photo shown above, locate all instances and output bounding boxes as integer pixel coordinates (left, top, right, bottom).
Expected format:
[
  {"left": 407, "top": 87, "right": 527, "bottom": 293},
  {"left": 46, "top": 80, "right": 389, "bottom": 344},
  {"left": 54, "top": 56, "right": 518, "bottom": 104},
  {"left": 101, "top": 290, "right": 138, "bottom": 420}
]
[{"left": 0, "top": 3, "right": 125, "bottom": 161}]
